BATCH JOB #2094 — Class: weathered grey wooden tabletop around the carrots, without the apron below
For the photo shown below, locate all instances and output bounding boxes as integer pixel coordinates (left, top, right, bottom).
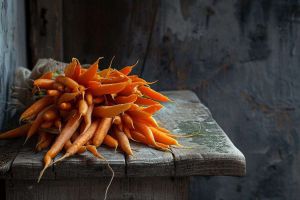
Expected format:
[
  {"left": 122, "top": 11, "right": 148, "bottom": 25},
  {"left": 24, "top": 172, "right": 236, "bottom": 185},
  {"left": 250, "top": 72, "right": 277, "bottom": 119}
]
[{"left": 7, "top": 91, "right": 246, "bottom": 179}]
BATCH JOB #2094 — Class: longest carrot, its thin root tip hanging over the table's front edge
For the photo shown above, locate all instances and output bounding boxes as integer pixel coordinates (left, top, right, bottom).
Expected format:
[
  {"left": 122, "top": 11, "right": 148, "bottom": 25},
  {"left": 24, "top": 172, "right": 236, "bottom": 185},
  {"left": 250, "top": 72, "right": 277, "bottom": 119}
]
[{"left": 38, "top": 113, "right": 81, "bottom": 182}]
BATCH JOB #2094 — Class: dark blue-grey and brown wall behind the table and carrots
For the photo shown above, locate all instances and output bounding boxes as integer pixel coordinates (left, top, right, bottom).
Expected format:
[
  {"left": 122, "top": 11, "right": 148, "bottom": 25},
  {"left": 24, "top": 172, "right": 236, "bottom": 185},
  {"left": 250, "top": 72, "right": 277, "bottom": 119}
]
[{"left": 0, "top": 0, "right": 300, "bottom": 200}]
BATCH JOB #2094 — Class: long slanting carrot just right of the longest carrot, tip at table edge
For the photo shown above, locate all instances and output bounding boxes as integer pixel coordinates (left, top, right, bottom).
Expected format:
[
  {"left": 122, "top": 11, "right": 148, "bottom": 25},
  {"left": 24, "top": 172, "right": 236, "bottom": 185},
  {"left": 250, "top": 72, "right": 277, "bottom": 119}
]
[{"left": 54, "top": 121, "right": 98, "bottom": 163}]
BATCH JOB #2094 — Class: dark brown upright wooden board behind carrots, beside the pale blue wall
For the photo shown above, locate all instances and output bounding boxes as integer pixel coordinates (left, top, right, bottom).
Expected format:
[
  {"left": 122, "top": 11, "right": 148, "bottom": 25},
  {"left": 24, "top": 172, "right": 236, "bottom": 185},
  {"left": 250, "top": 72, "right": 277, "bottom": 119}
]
[{"left": 28, "top": 0, "right": 63, "bottom": 66}]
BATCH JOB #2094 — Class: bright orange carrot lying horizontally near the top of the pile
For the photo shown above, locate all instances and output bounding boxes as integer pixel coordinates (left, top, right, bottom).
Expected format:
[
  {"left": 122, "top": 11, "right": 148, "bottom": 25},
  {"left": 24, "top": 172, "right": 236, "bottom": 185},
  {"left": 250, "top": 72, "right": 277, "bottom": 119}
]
[{"left": 88, "top": 81, "right": 128, "bottom": 96}]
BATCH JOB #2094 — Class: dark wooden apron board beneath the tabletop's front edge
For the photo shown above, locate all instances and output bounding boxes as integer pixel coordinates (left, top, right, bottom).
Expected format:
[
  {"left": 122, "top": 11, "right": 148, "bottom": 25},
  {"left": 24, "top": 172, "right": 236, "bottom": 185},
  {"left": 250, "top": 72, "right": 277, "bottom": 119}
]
[{"left": 6, "top": 177, "right": 189, "bottom": 200}]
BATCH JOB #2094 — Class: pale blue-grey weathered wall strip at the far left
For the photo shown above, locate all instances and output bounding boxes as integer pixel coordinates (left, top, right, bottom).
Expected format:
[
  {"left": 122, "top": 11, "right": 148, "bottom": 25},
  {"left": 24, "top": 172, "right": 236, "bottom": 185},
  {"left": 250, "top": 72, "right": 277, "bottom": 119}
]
[{"left": 0, "top": 0, "right": 26, "bottom": 127}]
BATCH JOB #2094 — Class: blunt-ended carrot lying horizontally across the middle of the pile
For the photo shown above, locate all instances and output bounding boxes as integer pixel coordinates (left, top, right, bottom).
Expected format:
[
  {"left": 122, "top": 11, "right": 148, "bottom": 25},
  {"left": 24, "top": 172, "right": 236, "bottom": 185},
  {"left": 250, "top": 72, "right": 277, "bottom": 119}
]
[{"left": 93, "top": 103, "right": 132, "bottom": 117}]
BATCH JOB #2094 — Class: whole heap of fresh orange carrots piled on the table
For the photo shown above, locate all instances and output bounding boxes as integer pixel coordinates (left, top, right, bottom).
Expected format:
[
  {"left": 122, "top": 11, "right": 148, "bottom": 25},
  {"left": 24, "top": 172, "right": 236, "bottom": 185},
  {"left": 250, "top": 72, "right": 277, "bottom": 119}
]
[{"left": 0, "top": 58, "right": 179, "bottom": 183}]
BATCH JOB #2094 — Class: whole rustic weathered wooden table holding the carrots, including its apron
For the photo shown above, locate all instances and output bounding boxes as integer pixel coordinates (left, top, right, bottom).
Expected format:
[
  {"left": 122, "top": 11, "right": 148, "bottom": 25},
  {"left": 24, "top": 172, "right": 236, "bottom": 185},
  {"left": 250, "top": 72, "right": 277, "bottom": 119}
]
[{"left": 0, "top": 90, "right": 246, "bottom": 200}]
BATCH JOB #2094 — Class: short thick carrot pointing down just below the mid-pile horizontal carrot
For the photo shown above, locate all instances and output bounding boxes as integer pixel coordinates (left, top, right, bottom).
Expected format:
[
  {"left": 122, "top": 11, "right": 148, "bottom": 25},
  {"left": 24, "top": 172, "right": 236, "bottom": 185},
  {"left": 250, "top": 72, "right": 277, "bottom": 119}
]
[{"left": 93, "top": 118, "right": 112, "bottom": 147}]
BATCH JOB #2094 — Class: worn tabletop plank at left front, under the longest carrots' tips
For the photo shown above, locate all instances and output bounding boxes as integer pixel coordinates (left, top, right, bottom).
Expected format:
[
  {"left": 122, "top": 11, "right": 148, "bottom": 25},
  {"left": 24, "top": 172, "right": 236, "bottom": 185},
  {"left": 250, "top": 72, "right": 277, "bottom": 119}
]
[{"left": 11, "top": 144, "right": 125, "bottom": 179}]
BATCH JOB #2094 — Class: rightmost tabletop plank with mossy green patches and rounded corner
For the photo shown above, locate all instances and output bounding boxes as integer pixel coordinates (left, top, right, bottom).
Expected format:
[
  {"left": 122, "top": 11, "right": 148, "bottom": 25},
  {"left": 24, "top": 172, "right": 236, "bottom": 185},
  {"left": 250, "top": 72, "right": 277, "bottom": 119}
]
[{"left": 156, "top": 91, "right": 246, "bottom": 176}]
